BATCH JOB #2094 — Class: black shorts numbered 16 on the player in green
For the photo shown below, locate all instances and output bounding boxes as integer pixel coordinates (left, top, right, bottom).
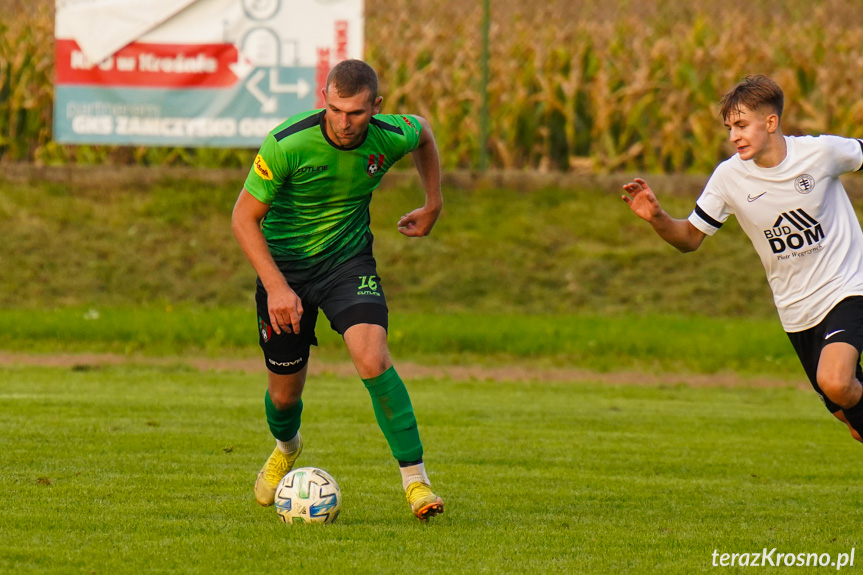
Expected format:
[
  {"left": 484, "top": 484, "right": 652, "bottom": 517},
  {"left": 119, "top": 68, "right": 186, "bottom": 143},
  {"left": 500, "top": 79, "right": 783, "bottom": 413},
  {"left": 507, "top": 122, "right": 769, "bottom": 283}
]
[{"left": 255, "top": 253, "right": 389, "bottom": 375}]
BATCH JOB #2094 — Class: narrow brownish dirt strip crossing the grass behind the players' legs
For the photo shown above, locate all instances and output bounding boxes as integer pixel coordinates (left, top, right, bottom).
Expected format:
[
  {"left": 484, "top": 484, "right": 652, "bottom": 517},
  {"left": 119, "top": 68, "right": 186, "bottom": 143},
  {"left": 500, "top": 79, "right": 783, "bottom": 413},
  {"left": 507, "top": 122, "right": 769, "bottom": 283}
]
[{"left": 0, "top": 351, "right": 810, "bottom": 389}]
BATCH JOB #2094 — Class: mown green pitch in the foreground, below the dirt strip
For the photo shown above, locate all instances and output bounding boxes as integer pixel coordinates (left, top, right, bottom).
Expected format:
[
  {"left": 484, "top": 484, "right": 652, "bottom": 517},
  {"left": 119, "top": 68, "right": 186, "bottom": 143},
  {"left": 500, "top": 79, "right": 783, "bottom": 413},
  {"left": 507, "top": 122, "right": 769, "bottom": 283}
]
[{"left": 0, "top": 367, "right": 863, "bottom": 574}]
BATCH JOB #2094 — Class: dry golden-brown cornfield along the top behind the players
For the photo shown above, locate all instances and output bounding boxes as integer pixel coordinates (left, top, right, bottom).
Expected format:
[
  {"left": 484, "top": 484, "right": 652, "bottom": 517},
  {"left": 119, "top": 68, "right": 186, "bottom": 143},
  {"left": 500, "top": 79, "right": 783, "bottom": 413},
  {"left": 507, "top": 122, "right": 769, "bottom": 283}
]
[{"left": 0, "top": 0, "right": 863, "bottom": 173}]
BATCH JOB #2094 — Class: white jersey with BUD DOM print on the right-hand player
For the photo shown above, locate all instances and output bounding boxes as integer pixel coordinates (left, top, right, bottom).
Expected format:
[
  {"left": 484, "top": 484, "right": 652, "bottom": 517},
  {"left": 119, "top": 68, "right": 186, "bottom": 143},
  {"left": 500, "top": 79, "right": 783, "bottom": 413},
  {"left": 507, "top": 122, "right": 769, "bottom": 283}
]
[{"left": 689, "top": 136, "right": 863, "bottom": 332}]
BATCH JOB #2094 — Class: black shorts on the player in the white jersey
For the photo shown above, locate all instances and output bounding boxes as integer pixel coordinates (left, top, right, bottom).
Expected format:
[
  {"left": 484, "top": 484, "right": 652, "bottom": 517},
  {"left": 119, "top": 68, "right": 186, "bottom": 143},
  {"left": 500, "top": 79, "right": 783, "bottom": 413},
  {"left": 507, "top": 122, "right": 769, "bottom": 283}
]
[{"left": 788, "top": 296, "right": 863, "bottom": 413}]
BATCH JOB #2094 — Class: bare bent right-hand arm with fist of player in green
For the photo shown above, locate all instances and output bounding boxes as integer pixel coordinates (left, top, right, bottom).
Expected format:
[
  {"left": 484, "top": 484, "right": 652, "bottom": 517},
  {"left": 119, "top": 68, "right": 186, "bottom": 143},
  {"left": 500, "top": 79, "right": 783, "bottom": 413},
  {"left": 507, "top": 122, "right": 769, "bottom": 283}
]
[{"left": 398, "top": 116, "right": 443, "bottom": 237}]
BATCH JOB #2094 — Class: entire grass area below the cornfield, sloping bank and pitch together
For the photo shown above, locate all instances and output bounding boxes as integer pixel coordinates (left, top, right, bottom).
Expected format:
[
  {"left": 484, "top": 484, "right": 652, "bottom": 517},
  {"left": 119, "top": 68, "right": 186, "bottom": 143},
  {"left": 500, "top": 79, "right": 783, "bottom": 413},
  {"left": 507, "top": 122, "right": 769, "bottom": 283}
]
[{"left": 6, "top": 165, "right": 863, "bottom": 575}]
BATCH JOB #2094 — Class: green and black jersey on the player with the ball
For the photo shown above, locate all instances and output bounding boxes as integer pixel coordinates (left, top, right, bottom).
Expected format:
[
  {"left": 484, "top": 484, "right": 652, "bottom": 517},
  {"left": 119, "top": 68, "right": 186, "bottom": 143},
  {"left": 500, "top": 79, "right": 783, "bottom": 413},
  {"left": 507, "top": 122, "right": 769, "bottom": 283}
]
[{"left": 245, "top": 110, "right": 422, "bottom": 275}]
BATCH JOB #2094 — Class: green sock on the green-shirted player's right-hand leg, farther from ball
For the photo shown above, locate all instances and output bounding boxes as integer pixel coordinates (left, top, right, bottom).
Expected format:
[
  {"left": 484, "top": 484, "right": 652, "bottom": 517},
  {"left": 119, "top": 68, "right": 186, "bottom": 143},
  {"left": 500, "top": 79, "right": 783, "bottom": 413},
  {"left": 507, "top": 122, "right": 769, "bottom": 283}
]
[{"left": 363, "top": 367, "right": 423, "bottom": 461}]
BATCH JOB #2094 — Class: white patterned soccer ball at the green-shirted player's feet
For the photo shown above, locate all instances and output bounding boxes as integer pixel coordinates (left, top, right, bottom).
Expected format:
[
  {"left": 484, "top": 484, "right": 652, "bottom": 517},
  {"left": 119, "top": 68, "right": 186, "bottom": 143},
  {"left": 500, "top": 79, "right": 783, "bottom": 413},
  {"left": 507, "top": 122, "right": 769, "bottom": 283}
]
[{"left": 275, "top": 467, "right": 342, "bottom": 523}]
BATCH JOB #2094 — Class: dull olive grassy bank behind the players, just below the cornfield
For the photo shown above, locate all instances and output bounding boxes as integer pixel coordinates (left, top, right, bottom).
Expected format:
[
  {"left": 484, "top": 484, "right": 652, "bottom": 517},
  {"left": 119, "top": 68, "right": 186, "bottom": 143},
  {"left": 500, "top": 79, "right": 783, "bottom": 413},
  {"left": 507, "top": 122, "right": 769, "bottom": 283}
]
[{"left": 0, "top": 168, "right": 775, "bottom": 318}]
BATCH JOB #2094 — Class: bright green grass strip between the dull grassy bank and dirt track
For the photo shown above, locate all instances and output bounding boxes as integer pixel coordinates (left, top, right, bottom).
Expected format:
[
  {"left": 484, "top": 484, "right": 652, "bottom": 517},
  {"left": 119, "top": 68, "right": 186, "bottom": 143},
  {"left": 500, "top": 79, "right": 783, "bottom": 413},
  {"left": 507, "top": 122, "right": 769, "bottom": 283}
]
[{"left": 0, "top": 306, "right": 802, "bottom": 379}]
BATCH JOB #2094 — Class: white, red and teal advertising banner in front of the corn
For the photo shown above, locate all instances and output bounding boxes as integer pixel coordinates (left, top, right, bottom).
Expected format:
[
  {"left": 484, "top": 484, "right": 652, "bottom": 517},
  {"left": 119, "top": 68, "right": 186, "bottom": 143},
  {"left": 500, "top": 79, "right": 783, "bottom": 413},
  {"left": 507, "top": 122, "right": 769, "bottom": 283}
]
[{"left": 54, "top": 0, "right": 363, "bottom": 148}]
